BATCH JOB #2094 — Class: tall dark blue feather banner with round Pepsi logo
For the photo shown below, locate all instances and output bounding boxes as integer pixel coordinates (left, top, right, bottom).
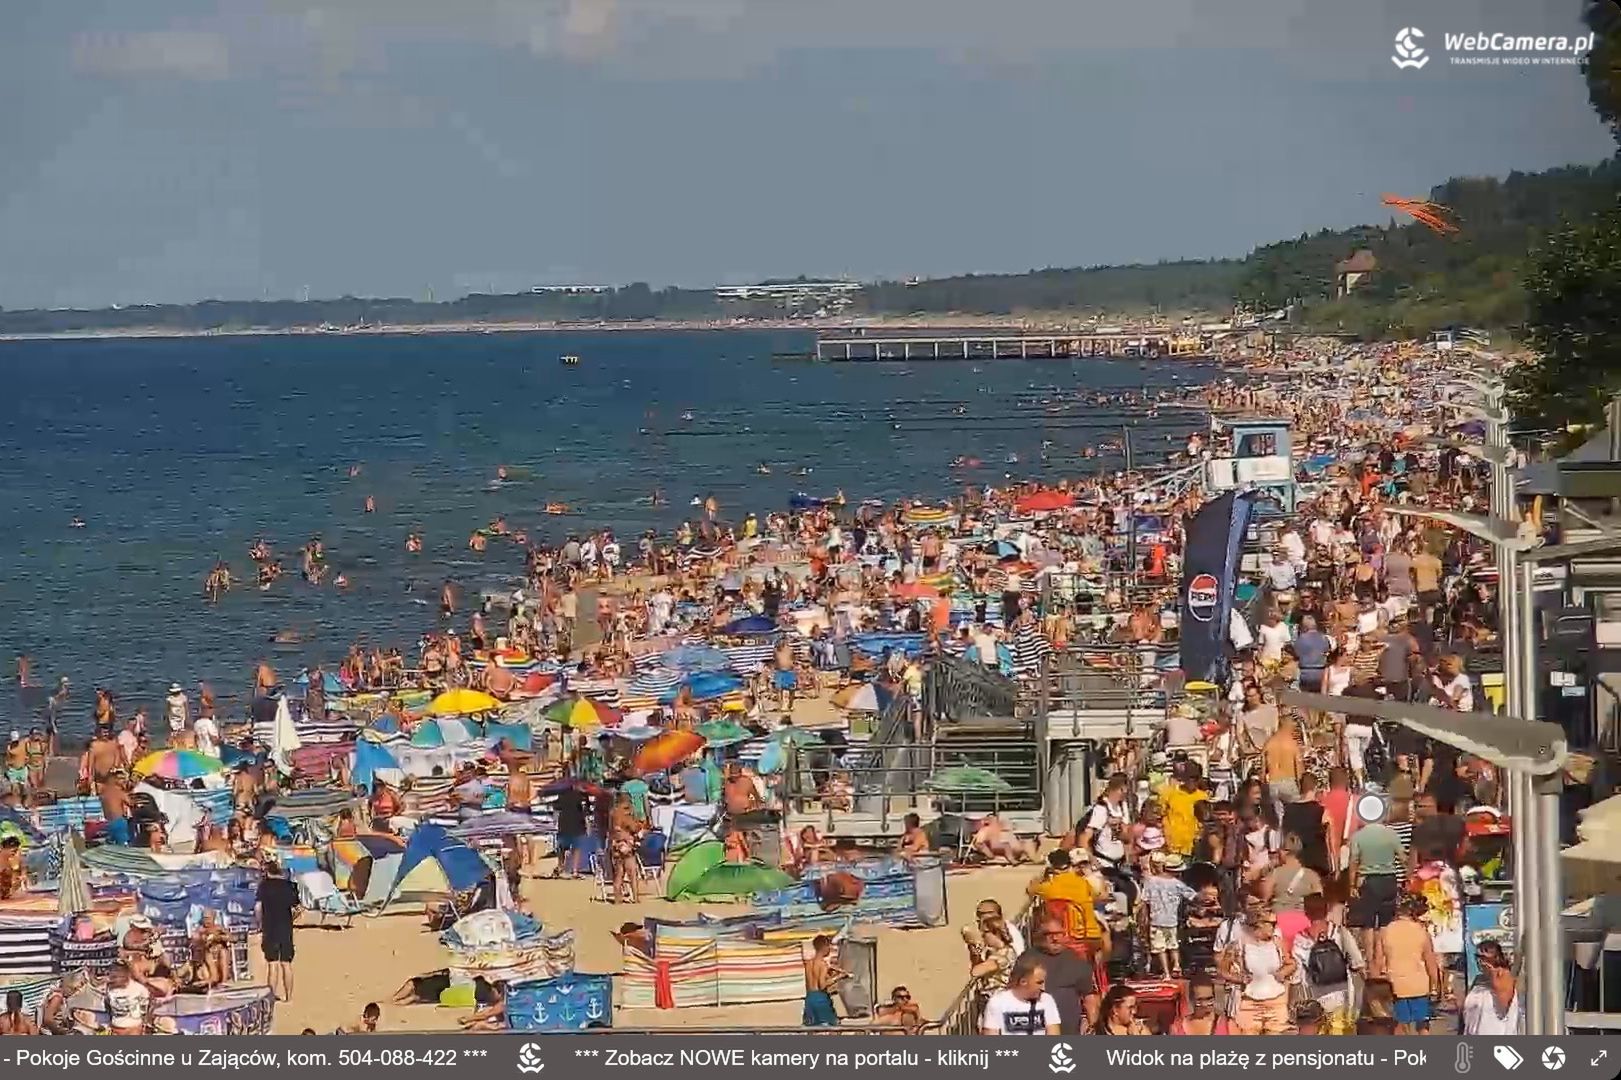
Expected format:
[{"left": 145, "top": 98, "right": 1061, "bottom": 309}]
[{"left": 1180, "top": 491, "right": 1255, "bottom": 684}]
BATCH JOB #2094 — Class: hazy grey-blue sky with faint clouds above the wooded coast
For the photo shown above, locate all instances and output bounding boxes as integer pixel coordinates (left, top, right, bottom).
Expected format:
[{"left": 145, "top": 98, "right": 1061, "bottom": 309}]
[{"left": 0, "top": 0, "right": 1615, "bottom": 308}]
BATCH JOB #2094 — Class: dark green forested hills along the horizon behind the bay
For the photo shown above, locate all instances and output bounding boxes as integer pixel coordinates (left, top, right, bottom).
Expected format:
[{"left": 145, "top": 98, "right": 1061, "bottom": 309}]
[{"left": 0, "top": 161, "right": 1621, "bottom": 337}]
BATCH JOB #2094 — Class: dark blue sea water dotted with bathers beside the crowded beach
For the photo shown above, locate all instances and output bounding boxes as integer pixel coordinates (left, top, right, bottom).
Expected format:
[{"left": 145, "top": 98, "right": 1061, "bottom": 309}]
[{"left": 0, "top": 332, "right": 1209, "bottom": 731}]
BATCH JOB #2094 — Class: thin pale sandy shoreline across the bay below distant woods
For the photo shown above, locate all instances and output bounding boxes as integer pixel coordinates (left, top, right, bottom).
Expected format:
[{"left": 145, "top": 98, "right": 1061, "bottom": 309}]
[{"left": 0, "top": 313, "right": 1238, "bottom": 342}]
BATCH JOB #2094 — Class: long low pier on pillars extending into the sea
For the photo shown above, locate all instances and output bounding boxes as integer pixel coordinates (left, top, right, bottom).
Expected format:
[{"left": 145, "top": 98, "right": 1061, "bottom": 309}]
[{"left": 804, "top": 329, "right": 1213, "bottom": 363}]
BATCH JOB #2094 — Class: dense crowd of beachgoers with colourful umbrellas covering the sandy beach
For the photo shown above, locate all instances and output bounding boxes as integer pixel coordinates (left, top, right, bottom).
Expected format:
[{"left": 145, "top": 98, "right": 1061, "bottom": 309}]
[{"left": 0, "top": 344, "right": 1582, "bottom": 1035}]
